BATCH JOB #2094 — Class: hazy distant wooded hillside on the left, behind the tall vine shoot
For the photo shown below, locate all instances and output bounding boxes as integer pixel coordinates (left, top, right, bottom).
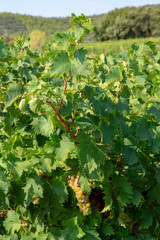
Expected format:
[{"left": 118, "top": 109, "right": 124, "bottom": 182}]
[{"left": 0, "top": 13, "right": 103, "bottom": 40}]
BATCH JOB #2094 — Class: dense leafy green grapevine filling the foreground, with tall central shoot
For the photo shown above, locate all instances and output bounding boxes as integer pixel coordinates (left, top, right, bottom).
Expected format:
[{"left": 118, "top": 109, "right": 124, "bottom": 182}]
[{"left": 0, "top": 14, "right": 160, "bottom": 240}]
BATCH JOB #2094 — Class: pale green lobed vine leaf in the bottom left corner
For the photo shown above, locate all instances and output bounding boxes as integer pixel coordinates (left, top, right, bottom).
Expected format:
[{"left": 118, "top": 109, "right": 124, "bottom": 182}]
[{"left": 3, "top": 210, "right": 22, "bottom": 234}]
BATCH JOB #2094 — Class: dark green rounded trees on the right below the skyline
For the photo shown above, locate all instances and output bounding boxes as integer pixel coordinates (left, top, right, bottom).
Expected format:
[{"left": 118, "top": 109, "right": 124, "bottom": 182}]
[{"left": 98, "top": 5, "right": 160, "bottom": 41}]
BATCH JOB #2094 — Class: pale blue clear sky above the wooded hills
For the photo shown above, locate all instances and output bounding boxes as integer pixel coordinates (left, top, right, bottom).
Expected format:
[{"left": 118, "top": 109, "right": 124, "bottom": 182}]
[{"left": 0, "top": 0, "right": 160, "bottom": 17}]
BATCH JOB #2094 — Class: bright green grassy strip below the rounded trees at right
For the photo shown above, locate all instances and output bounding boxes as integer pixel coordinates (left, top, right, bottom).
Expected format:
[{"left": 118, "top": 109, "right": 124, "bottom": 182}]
[{"left": 83, "top": 37, "right": 160, "bottom": 55}]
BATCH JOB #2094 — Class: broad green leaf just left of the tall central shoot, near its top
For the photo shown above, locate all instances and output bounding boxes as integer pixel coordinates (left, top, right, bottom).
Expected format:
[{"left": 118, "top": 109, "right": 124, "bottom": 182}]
[{"left": 51, "top": 51, "right": 71, "bottom": 75}]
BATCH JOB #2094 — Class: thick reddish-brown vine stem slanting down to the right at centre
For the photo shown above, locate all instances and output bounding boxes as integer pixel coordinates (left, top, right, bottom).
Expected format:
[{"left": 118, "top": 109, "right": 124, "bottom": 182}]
[{"left": 46, "top": 99, "right": 77, "bottom": 139}]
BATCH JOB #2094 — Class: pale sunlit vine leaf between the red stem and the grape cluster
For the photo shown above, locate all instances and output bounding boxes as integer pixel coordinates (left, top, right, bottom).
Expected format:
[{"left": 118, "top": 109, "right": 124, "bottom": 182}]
[{"left": 55, "top": 135, "right": 75, "bottom": 161}]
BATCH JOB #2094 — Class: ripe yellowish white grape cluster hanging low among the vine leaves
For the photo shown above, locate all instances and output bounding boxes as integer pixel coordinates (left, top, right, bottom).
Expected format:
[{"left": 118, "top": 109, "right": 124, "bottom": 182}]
[{"left": 68, "top": 173, "right": 91, "bottom": 215}]
